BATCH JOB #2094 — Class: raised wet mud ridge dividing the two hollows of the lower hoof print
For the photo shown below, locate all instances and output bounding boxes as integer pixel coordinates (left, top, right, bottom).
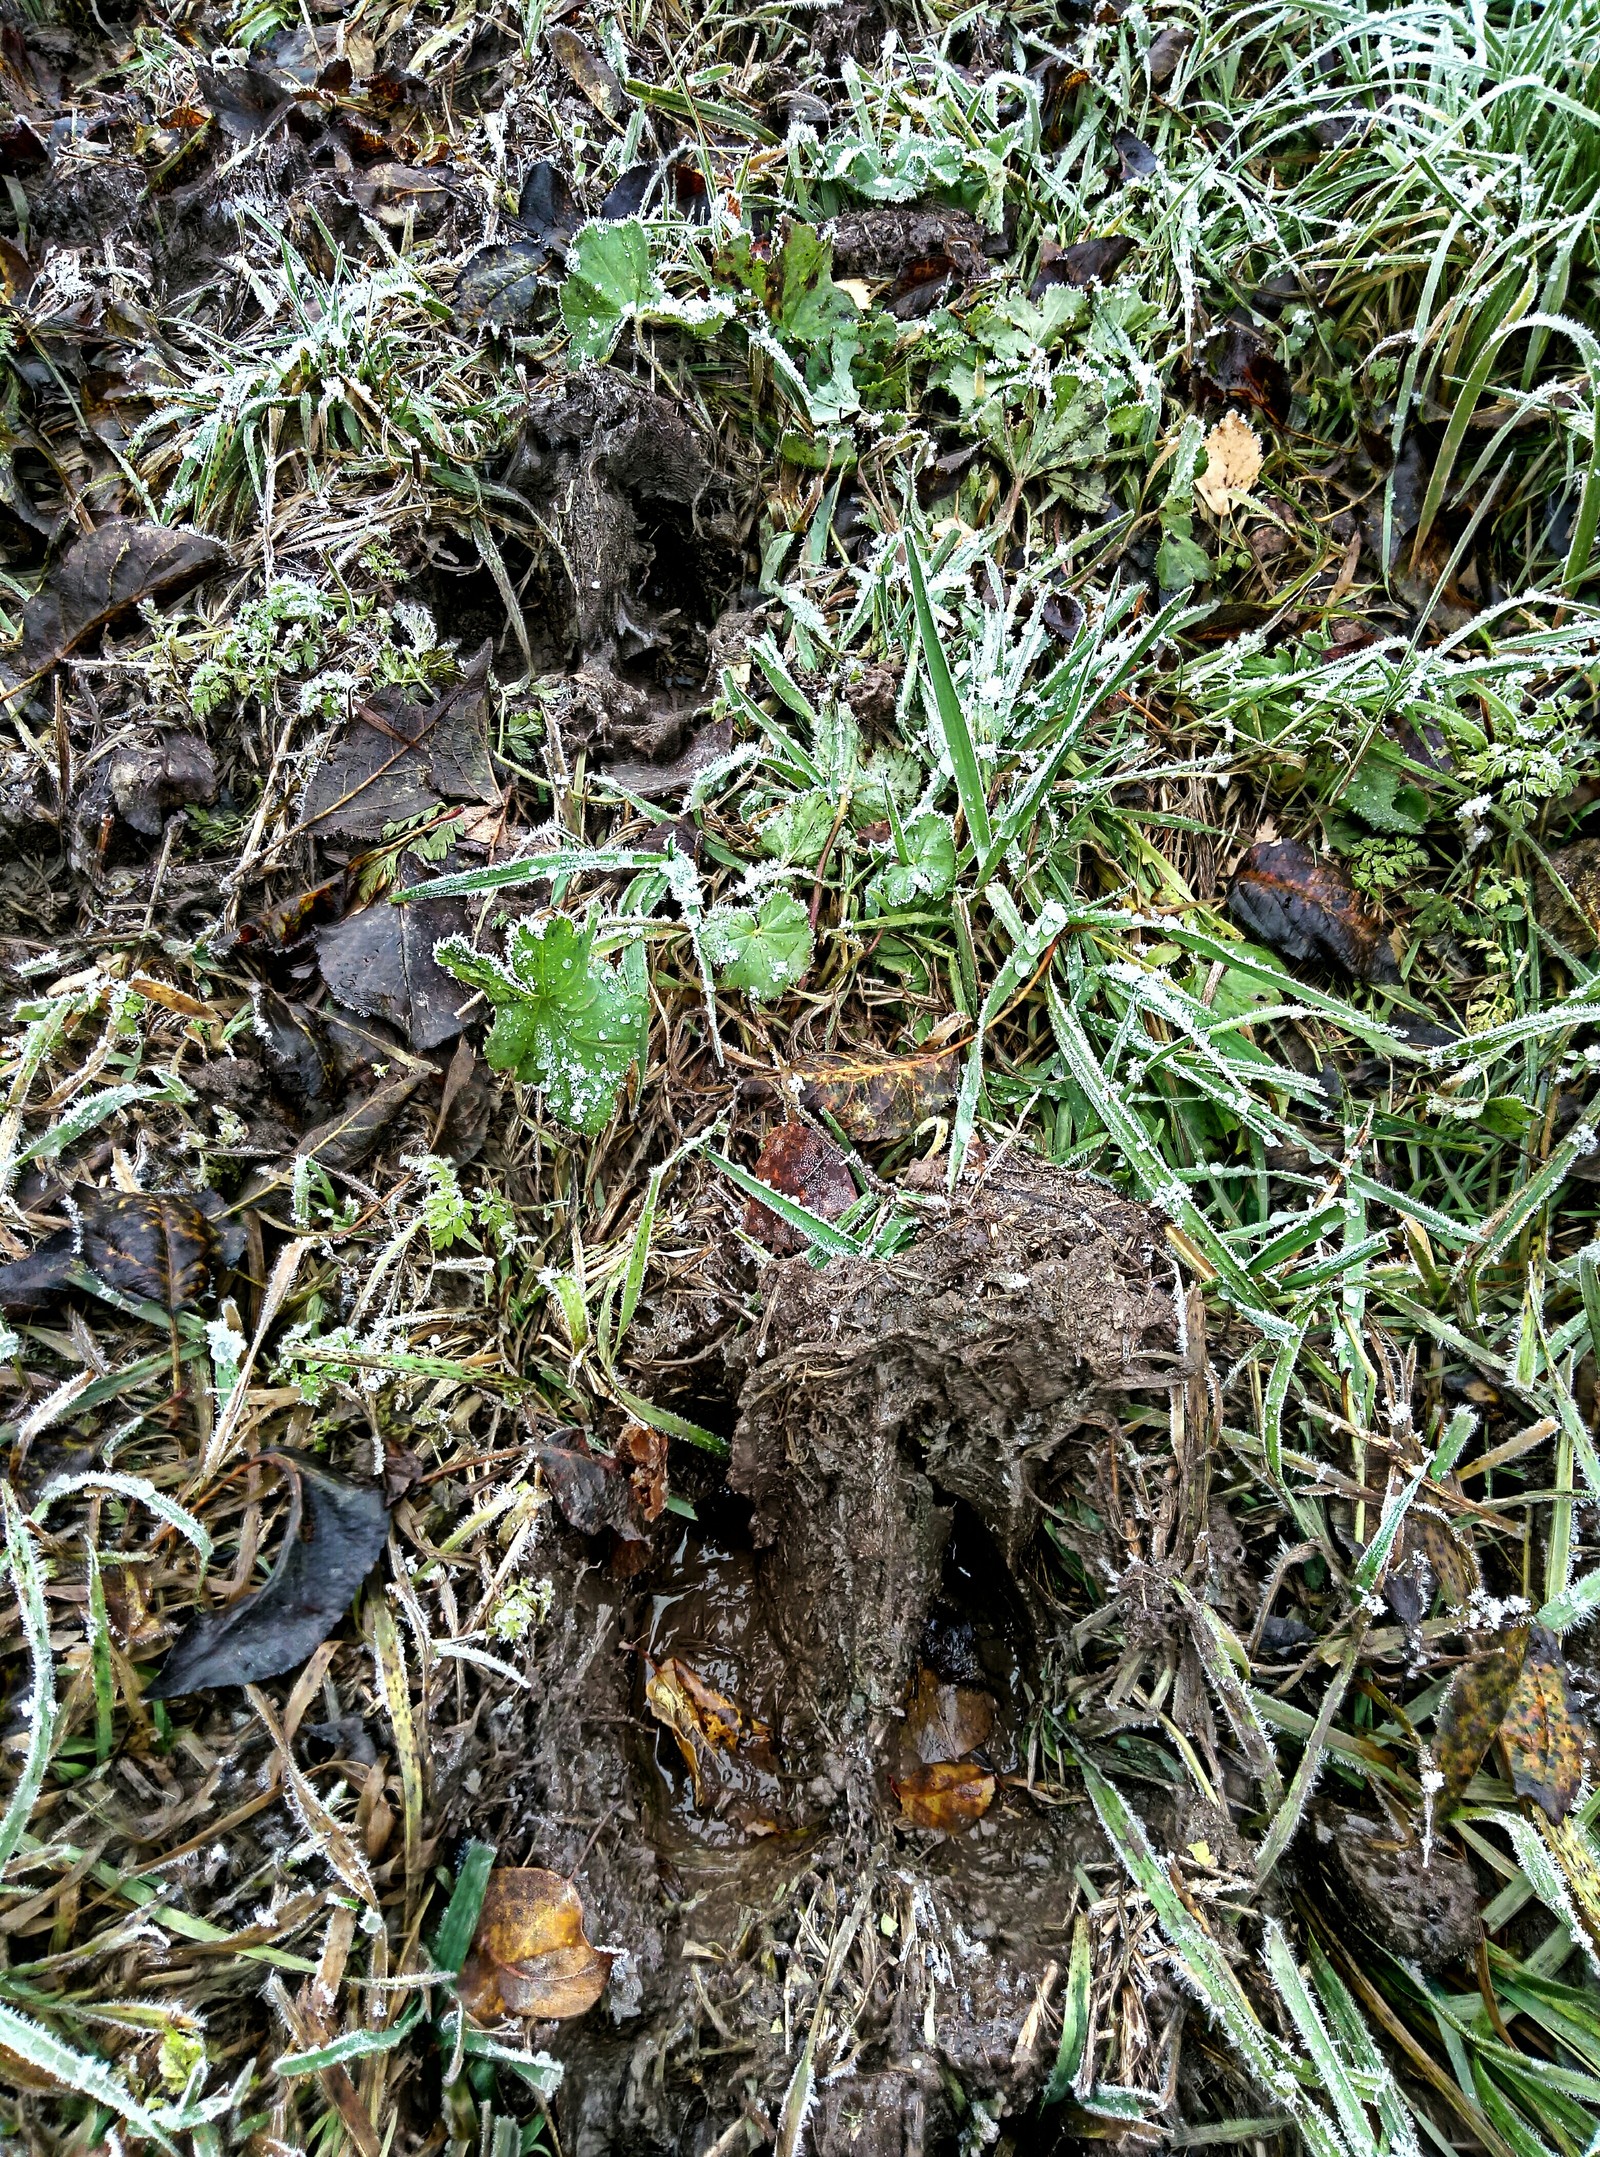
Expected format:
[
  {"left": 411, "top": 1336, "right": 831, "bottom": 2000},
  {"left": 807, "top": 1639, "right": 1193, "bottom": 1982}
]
[{"left": 729, "top": 1163, "right": 1180, "bottom": 1825}]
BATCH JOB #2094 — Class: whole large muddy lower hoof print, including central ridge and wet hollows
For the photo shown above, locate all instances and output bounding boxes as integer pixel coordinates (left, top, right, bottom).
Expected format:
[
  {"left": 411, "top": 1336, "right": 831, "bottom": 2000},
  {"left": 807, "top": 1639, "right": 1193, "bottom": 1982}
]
[{"left": 500, "top": 1160, "right": 1184, "bottom": 2157}]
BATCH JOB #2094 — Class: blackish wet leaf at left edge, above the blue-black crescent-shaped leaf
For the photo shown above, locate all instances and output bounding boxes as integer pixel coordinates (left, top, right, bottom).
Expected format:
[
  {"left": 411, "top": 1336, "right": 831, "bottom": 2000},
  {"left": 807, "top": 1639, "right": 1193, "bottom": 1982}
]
[{"left": 0, "top": 1191, "right": 220, "bottom": 1311}]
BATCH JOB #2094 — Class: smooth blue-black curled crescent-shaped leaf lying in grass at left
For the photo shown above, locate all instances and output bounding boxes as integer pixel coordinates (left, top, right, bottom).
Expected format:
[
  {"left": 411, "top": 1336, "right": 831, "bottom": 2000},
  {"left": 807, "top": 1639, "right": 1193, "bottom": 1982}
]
[{"left": 144, "top": 1452, "right": 388, "bottom": 1700}]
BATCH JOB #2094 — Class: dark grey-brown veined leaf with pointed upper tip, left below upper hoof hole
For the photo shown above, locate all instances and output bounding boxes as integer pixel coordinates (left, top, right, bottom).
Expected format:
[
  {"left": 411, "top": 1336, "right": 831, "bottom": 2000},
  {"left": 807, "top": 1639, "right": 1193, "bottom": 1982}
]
[{"left": 306, "top": 643, "right": 500, "bottom": 839}]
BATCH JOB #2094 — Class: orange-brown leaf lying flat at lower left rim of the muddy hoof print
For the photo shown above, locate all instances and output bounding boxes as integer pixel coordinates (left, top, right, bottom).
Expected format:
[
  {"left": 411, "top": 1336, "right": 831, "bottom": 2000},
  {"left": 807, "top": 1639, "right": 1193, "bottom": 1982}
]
[{"left": 459, "top": 1866, "right": 615, "bottom": 2021}]
